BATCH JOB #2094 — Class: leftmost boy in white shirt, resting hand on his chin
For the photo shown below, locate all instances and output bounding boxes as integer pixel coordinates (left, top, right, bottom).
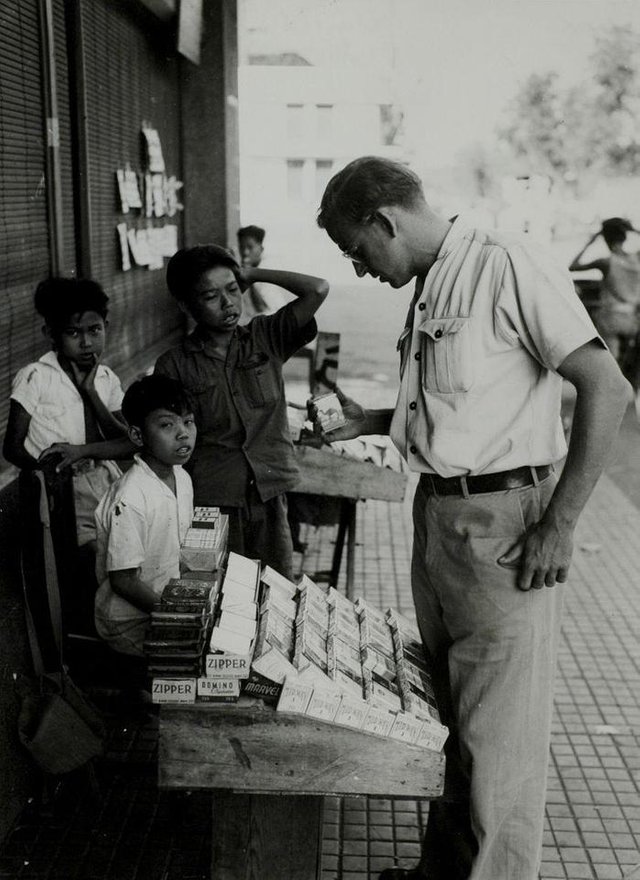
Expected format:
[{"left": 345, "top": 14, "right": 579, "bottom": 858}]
[{"left": 3, "top": 278, "right": 130, "bottom": 546}]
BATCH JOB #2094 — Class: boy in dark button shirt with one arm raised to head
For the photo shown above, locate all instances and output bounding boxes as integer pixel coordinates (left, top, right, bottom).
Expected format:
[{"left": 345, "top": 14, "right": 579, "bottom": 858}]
[{"left": 156, "top": 245, "right": 329, "bottom": 577}]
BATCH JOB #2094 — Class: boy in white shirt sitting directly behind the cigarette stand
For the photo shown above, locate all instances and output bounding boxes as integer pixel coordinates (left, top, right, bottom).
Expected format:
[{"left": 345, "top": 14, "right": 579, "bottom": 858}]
[{"left": 95, "top": 376, "right": 196, "bottom": 655}]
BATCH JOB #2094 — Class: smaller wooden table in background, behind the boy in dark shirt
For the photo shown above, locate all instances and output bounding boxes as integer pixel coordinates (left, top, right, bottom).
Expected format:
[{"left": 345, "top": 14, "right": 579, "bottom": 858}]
[{"left": 296, "top": 446, "right": 407, "bottom": 599}]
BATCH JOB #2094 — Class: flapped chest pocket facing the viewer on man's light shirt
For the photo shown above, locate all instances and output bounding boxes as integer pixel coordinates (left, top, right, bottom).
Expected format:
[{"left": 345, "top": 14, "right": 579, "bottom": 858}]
[{"left": 418, "top": 316, "right": 473, "bottom": 394}]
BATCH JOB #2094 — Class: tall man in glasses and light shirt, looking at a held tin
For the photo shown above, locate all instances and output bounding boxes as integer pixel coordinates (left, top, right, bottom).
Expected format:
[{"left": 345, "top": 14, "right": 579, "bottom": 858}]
[{"left": 318, "top": 157, "right": 629, "bottom": 880}]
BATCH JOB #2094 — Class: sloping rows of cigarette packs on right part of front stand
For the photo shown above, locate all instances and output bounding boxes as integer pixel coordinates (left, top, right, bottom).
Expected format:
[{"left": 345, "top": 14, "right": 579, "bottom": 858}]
[{"left": 245, "top": 567, "right": 448, "bottom": 751}]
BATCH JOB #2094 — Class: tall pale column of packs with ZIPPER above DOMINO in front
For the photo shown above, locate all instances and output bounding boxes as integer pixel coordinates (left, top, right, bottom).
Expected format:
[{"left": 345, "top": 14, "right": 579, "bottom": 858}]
[{"left": 196, "top": 553, "right": 260, "bottom": 703}]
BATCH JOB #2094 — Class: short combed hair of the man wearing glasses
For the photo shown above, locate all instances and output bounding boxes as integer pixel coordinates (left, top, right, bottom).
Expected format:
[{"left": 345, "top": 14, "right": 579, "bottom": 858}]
[{"left": 317, "top": 156, "right": 424, "bottom": 234}]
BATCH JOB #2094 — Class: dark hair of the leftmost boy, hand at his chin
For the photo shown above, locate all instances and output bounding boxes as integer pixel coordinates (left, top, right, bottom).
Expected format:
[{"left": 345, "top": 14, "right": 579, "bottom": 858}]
[{"left": 33, "top": 278, "right": 109, "bottom": 332}]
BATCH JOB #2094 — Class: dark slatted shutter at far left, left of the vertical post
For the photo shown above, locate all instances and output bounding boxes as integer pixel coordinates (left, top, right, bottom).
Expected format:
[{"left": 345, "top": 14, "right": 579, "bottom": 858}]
[{"left": 0, "top": 0, "right": 50, "bottom": 464}]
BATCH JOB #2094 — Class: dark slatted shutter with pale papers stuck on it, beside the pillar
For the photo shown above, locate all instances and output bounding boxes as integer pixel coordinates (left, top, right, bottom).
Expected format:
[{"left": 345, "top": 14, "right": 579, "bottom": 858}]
[{"left": 80, "top": 0, "right": 181, "bottom": 385}]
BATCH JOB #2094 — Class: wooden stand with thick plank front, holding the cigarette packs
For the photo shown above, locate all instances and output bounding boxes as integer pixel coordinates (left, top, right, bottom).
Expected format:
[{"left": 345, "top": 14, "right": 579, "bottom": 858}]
[{"left": 158, "top": 701, "right": 444, "bottom": 880}]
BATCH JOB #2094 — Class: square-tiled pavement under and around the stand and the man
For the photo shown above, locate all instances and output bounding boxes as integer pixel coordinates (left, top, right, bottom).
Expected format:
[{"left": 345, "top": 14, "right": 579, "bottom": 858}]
[{"left": 0, "top": 477, "right": 640, "bottom": 880}]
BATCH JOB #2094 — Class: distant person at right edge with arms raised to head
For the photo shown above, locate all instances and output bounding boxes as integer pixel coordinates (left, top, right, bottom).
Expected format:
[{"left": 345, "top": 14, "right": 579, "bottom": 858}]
[{"left": 569, "top": 217, "right": 640, "bottom": 387}]
